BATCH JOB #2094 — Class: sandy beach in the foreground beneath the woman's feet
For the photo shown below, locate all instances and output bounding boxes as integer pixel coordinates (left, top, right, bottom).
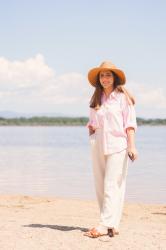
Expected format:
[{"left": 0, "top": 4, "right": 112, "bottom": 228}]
[{"left": 0, "top": 195, "right": 166, "bottom": 250}]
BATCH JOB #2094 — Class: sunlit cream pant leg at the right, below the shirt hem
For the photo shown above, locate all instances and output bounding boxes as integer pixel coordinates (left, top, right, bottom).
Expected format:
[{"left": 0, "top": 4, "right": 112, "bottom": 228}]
[{"left": 100, "top": 150, "right": 128, "bottom": 230}]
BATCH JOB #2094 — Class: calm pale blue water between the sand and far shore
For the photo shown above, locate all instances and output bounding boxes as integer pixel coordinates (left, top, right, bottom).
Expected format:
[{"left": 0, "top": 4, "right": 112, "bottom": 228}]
[{"left": 0, "top": 126, "right": 166, "bottom": 203}]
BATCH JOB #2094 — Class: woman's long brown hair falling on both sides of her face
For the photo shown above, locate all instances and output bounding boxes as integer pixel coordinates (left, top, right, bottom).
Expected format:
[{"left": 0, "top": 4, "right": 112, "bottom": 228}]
[{"left": 90, "top": 71, "right": 135, "bottom": 109}]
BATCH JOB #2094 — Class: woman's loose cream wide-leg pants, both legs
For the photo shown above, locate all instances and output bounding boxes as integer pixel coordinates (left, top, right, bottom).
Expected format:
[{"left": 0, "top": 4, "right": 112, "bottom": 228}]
[{"left": 90, "top": 129, "right": 128, "bottom": 230}]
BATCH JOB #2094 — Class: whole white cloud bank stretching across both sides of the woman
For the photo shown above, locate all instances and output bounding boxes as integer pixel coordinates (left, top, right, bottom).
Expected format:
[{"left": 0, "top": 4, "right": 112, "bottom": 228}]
[{"left": 0, "top": 54, "right": 166, "bottom": 116}]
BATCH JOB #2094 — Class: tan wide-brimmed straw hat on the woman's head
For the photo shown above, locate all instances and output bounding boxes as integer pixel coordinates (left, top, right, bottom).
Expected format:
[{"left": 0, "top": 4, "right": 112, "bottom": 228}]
[{"left": 88, "top": 61, "right": 126, "bottom": 87}]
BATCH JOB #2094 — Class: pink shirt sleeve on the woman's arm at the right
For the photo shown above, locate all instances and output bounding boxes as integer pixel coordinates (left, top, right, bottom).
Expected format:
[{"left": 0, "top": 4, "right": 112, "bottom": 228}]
[{"left": 122, "top": 96, "right": 137, "bottom": 131}]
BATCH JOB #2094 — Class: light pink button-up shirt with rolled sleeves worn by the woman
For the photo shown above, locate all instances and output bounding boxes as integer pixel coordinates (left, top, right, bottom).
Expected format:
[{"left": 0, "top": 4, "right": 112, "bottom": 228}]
[{"left": 86, "top": 91, "right": 137, "bottom": 155}]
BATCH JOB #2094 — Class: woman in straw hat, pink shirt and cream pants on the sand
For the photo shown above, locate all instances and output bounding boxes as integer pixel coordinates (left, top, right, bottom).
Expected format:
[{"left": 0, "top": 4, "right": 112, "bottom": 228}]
[{"left": 84, "top": 62, "right": 137, "bottom": 238}]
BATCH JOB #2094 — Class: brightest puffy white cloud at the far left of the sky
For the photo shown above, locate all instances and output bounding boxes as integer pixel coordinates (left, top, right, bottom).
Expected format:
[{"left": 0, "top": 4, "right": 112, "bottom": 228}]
[{"left": 0, "top": 54, "right": 55, "bottom": 91}]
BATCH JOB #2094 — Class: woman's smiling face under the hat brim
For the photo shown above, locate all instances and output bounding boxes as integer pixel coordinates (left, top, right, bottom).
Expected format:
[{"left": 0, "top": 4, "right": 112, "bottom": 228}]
[{"left": 99, "top": 70, "right": 114, "bottom": 89}]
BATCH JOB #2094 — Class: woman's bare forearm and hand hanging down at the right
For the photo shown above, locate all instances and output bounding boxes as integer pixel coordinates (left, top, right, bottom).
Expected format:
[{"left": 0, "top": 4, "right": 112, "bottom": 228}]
[{"left": 126, "top": 127, "right": 138, "bottom": 161}]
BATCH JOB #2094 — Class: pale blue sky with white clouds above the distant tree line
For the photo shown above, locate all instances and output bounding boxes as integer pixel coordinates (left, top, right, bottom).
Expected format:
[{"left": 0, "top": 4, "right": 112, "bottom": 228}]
[{"left": 0, "top": 0, "right": 166, "bottom": 118}]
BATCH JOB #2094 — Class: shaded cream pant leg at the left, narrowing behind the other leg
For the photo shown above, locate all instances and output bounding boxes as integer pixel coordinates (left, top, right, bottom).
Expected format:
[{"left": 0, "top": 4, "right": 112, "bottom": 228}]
[{"left": 90, "top": 129, "right": 106, "bottom": 212}]
